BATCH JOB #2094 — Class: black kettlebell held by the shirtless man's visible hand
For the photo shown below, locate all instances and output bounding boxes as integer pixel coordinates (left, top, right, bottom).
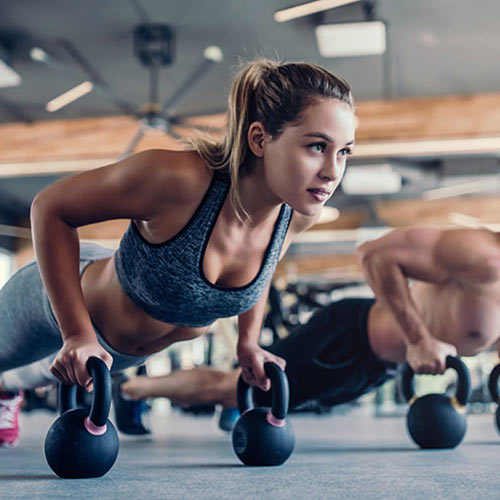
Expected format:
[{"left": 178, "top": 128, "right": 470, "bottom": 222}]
[{"left": 401, "top": 356, "right": 470, "bottom": 448}]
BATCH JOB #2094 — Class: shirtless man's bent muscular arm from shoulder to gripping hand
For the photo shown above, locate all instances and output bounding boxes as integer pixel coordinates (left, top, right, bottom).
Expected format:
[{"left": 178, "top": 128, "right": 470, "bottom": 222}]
[{"left": 358, "top": 227, "right": 500, "bottom": 373}]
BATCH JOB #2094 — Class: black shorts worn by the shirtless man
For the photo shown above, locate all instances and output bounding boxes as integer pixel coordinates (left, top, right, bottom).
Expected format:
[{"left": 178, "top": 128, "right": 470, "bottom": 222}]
[{"left": 254, "top": 298, "right": 397, "bottom": 408}]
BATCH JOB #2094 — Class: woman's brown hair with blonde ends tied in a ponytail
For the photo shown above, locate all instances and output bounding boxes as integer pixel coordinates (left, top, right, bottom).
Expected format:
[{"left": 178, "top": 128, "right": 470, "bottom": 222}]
[{"left": 187, "top": 59, "right": 354, "bottom": 216}]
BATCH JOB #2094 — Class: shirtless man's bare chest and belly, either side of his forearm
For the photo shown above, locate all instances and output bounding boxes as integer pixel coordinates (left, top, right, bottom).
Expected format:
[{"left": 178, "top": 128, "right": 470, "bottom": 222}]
[{"left": 368, "top": 281, "right": 500, "bottom": 363}]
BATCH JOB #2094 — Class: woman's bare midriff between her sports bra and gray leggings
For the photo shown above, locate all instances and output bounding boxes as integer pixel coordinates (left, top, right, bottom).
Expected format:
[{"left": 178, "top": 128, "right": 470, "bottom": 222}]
[{"left": 81, "top": 257, "right": 209, "bottom": 356}]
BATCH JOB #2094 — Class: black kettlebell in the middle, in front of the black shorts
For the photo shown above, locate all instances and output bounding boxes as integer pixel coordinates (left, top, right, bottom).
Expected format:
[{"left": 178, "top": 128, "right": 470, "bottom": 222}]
[{"left": 233, "top": 362, "right": 295, "bottom": 465}]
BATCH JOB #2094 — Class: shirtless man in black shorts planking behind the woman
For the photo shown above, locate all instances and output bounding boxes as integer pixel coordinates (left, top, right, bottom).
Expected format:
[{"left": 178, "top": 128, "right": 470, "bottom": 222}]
[{"left": 109, "top": 226, "right": 500, "bottom": 414}]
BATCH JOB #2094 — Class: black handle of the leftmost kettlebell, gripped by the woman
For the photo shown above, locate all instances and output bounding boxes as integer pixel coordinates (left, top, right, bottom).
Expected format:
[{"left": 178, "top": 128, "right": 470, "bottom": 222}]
[{"left": 59, "top": 356, "right": 112, "bottom": 427}]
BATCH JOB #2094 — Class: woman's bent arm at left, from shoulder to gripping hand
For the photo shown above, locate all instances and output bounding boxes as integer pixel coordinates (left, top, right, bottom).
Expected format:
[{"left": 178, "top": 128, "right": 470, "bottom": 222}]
[{"left": 31, "top": 151, "right": 207, "bottom": 385}]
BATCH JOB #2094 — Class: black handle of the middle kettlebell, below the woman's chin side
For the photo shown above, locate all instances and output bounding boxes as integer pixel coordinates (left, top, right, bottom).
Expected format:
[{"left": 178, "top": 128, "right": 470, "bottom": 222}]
[{"left": 236, "top": 361, "right": 290, "bottom": 420}]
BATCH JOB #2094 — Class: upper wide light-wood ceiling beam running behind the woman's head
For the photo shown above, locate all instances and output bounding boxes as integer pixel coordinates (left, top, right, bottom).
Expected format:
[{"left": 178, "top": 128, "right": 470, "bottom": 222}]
[{"left": 0, "top": 93, "right": 500, "bottom": 177}]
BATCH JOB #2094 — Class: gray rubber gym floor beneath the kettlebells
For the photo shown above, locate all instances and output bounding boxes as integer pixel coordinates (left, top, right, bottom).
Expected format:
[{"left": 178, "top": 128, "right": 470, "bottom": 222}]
[{"left": 0, "top": 412, "right": 500, "bottom": 500}]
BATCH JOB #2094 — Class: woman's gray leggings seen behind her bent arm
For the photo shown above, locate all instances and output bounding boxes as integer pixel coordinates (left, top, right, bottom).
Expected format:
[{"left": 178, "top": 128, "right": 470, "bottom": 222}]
[{"left": 0, "top": 243, "right": 147, "bottom": 391}]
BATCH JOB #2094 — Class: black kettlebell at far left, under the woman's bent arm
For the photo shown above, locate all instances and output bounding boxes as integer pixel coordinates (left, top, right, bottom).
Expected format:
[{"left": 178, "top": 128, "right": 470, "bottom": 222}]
[{"left": 45, "top": 357, "right": 118, "bottom": 478}]
